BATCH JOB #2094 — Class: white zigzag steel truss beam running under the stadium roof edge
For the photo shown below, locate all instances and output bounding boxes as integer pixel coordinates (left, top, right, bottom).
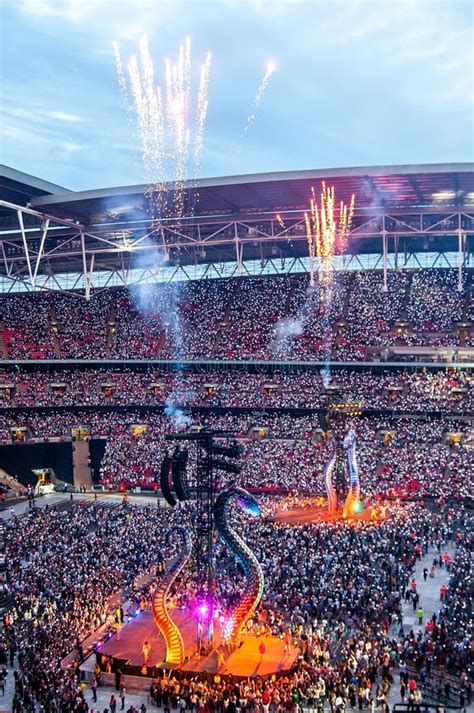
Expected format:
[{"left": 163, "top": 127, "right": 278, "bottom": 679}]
[{"left": 0, "top": 201, "right": 474, "bottom": 298}]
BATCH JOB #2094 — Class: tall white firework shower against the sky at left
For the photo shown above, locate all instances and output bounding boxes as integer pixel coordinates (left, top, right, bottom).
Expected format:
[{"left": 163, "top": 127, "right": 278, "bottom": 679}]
[{"left": 114, "top": 35, "right": 212, "bottom": 220}]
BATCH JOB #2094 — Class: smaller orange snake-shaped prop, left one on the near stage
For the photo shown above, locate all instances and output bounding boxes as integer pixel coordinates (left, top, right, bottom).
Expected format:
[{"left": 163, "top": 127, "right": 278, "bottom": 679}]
[{"left": 151, "top": 527, "right": 191, "bottom": 665}]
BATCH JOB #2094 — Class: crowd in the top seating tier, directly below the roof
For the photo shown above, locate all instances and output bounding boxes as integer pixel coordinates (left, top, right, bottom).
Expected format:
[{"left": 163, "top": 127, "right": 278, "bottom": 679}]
[{"left": 0, "top": 269, "right": 472, "bottom": 361}]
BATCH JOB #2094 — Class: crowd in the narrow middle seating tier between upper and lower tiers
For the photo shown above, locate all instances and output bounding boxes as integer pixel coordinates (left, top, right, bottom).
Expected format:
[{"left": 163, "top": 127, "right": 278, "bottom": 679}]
[{"left": 0, "top": 366, "right": 474, "bottom": 413}]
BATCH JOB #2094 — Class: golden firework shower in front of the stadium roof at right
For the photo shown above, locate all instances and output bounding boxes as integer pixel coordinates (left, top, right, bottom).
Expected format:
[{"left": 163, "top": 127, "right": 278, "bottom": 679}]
[{"left": 304, "top": 181, "right": 355, "bottom": 286}]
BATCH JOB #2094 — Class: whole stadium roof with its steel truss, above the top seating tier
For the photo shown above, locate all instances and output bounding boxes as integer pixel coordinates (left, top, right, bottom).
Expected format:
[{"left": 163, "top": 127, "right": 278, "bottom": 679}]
[{"left": 0, "top": 163, "right": 474, "bottom": 290}]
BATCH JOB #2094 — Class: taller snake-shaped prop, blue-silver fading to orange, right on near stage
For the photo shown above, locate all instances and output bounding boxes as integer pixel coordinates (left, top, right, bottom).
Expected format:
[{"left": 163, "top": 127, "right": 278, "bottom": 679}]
[{"left": 214, "top": 486, "right": 263, "bottom": 649}]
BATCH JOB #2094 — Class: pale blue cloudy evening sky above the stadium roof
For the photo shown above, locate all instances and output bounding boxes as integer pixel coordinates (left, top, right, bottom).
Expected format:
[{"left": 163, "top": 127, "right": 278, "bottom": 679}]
[{"left": 0, "top": 0, "right": 474, "bottom": 190}]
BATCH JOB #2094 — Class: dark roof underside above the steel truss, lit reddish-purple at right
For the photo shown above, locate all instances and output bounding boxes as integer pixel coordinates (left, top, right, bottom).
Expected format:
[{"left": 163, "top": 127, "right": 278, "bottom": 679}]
[{"left": 31, "top": 163, "right": 474, "bottom": 220}]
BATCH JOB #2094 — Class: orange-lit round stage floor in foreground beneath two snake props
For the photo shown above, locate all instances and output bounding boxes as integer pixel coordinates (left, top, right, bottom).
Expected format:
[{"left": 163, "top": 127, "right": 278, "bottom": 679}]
[{"left": 97, "top": 609, "right": 298, "bottom": 678}]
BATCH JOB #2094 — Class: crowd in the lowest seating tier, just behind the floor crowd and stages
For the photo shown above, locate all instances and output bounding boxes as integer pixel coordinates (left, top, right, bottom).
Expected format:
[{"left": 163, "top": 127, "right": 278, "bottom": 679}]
[{"left": 0, "top": 408, "right": 474, "bottom": 498}]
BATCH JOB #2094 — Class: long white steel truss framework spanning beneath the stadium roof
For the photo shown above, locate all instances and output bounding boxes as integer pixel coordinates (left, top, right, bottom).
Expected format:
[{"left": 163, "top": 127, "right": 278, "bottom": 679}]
[{"left": 0, "top": 201, "right": 474, "bottom": 299}]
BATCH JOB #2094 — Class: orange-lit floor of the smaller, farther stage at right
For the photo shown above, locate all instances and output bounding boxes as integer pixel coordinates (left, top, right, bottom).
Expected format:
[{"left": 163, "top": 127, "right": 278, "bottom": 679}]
[{"left": 273, "top": 498, "right": 390, "bottom": 525}]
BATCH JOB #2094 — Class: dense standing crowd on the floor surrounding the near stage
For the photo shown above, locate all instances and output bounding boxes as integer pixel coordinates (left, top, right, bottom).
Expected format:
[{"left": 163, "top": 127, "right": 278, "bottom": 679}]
[{"left": 0, "top": 498, "right": 472, "bottom": 713}]
